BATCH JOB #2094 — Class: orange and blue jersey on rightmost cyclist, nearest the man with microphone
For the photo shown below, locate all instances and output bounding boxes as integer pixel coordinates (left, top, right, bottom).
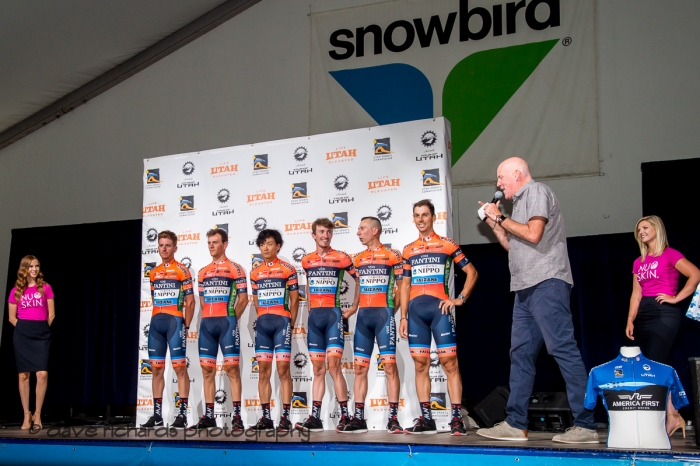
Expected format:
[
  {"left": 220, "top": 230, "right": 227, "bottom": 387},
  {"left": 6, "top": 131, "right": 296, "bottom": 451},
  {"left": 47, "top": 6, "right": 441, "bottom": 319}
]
[{"left": 403, "top": 233, "right": 469, "bottom": 300}]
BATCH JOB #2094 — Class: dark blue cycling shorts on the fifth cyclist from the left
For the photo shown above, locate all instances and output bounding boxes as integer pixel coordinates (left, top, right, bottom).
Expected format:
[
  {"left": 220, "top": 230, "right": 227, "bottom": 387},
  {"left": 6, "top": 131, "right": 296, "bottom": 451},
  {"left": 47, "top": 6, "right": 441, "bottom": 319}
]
[{"left": 354, "top": 307, "right": 396, "bottom": 366}]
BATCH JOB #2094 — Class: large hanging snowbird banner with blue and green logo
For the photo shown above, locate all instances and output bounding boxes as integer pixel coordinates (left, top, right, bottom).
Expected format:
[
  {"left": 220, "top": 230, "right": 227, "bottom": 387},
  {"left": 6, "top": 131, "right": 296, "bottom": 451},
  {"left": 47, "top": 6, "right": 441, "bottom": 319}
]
[{"left": 309, "top": 0, "right": 599, "bottom": 186}]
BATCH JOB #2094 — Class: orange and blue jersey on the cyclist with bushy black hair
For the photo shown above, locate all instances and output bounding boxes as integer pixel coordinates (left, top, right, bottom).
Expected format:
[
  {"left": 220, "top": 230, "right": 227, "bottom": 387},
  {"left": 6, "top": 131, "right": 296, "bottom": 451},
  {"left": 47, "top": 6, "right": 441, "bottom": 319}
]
[{"left": 250, "top": 258, "right": 299, "bottom": 317}]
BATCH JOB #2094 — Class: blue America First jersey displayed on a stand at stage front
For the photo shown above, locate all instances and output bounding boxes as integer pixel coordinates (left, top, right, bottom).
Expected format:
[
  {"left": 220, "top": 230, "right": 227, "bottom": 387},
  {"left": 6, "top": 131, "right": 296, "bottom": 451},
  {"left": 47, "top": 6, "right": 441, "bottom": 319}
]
[{"left": 583, "top": 353, "right": 688, "bottom": 450}]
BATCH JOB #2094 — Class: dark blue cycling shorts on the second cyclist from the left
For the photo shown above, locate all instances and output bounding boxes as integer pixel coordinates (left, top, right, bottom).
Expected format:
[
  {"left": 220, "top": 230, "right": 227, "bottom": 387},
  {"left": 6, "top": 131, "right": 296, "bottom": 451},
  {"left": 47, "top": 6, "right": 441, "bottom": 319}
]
[{"left": 199, "top": 316, "right": 241, "bottom": 367}]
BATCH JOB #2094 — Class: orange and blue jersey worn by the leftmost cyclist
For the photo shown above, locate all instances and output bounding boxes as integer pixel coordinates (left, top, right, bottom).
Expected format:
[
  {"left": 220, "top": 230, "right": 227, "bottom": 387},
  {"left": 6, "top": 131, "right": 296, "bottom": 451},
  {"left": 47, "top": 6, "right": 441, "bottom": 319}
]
[{"left": 151, "top": 260, "right": 194, "bottom": 317}]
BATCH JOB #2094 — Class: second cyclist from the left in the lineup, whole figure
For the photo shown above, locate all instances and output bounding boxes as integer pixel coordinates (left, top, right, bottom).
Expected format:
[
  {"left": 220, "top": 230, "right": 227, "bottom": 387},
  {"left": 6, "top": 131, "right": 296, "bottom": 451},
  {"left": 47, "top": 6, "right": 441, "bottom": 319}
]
[{"left": 191, "top": 228, "right": 248, "bottom": 431}]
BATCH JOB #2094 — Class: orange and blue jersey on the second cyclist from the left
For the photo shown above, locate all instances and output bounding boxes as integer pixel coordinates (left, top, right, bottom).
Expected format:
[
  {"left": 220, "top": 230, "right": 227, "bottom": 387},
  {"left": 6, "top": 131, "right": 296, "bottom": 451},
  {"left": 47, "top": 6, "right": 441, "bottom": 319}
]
[{"left": 198, "top": 259, "right": 248, "bottom": 317}]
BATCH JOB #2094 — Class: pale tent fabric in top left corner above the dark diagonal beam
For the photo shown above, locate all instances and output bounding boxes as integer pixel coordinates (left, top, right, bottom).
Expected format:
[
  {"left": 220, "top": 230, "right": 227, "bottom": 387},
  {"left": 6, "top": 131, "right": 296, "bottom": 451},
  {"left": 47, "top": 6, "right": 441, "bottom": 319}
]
[{"left": 0, "top": 0, "right": 224, "bottom": 132}]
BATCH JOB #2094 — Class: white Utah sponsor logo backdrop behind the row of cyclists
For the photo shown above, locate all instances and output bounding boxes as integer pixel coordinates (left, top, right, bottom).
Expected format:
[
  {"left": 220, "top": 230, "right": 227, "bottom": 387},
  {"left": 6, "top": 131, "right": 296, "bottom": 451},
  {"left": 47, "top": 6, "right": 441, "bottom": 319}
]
[{"left": 137, "top": 118, "right": 452, "bottom": 429}]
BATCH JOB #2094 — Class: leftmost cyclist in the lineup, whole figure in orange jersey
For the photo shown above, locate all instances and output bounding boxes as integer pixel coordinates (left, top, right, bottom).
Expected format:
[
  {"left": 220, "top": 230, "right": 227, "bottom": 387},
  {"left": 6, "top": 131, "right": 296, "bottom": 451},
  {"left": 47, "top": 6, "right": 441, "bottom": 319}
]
[{"left": 141, "top": 230, "right": 194, "bottom": 428}]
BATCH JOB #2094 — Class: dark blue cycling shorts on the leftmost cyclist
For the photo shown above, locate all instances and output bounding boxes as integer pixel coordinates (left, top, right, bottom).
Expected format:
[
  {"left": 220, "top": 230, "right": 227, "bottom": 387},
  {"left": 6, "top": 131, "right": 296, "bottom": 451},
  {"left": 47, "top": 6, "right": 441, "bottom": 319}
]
[{"left": 148, "top": 313, "right": 187, "bottom": 367}]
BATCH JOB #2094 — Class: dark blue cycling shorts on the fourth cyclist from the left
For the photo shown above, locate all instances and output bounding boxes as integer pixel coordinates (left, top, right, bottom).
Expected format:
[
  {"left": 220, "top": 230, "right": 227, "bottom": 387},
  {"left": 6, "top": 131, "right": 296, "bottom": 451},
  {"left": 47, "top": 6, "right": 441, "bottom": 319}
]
[{"left": 308, "top": 307, "right": 345, "bottom": 361}]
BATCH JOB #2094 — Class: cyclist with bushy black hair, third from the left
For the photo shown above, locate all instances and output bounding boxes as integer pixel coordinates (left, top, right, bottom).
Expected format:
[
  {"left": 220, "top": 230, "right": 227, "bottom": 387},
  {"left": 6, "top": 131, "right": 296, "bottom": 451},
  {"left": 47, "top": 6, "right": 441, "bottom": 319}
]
[{"left": 250, "top": 230, "right": 299, "bottom": 432}]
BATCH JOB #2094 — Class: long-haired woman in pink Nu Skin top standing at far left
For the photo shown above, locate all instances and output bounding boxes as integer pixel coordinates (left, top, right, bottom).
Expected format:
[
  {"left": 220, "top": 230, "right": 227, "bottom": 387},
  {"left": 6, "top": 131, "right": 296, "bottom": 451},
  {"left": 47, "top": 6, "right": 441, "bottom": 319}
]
[{"left": 8, "top": 256, "right": 54, "bottom": 430}]
